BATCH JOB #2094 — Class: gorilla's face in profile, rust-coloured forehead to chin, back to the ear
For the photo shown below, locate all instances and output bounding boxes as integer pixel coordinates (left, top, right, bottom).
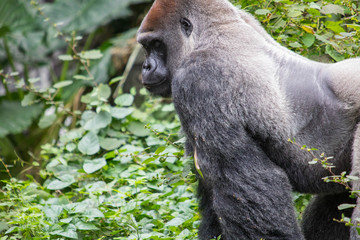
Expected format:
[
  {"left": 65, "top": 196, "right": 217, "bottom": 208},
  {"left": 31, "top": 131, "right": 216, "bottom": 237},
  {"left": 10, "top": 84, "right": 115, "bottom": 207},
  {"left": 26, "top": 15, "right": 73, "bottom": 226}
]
[{"left": 137, "top": 0, "right": 193, "bottom": 97}]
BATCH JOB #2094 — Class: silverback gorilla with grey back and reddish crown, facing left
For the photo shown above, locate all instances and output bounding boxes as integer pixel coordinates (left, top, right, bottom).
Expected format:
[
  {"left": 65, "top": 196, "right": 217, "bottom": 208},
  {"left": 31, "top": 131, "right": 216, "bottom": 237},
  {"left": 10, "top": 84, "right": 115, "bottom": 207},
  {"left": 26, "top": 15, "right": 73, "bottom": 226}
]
[{"left": 138, "top": 0, "right": 360, "bottom": 240}]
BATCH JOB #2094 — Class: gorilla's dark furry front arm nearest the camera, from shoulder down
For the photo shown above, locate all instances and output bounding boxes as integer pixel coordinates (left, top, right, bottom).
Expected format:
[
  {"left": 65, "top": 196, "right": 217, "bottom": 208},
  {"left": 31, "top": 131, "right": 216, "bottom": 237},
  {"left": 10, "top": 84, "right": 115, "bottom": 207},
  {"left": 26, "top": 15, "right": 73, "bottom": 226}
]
[{"left": 172, "top": 52, "right": 302, "bottom": 240}]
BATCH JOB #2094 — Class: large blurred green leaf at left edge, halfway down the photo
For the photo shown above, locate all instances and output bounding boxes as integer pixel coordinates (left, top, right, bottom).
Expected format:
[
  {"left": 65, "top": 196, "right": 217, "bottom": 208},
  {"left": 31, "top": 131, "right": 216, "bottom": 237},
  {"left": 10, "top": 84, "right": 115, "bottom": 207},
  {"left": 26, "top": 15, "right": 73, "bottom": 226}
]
[{"left": 0, "top": 101, "right": 43, "bottom": 137}]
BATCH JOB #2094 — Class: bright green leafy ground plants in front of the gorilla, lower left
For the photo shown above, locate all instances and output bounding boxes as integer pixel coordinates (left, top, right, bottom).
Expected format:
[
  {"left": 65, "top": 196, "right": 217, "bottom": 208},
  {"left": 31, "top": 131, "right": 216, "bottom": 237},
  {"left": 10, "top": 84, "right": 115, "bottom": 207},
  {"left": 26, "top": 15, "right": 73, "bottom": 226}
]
[{"left": 1, "top": 79, "right": 199, "bottom": 239}]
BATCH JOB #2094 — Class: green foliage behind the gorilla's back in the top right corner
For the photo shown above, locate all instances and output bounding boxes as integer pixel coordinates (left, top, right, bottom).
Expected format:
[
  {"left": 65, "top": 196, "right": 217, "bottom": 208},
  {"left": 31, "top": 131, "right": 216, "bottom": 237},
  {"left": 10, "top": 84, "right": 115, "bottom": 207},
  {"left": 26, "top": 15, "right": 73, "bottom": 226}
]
[{"left": 233, "top": 0, "right": 360, "bottom": 62}]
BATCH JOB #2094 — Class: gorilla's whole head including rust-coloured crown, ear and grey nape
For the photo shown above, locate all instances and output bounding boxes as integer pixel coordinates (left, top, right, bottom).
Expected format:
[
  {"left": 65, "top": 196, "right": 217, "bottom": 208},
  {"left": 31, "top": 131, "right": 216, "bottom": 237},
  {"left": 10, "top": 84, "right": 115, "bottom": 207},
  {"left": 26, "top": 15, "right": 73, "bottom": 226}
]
[{"left": 137, "top": 0, "right": 233, "bottom": 96}]
